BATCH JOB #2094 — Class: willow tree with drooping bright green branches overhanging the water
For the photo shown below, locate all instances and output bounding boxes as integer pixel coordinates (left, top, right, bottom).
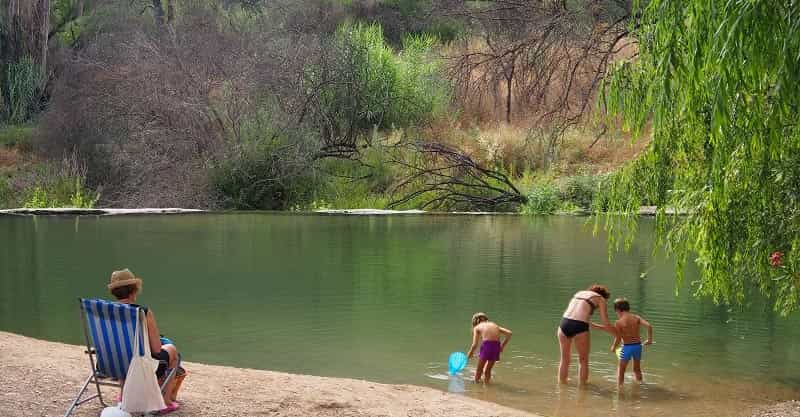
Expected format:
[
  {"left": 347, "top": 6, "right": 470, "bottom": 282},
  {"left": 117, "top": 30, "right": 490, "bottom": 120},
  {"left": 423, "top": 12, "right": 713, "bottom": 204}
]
[{"left": 604, "top": 0, "right": 800, "bottom": 314}]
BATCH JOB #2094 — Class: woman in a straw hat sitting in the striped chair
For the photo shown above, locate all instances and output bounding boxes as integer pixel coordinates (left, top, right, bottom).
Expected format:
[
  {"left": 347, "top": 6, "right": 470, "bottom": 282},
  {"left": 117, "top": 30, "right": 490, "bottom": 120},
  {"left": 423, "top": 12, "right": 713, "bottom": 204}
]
[{"left": 108, "top": 268, "right": 180, "bottom": 413}]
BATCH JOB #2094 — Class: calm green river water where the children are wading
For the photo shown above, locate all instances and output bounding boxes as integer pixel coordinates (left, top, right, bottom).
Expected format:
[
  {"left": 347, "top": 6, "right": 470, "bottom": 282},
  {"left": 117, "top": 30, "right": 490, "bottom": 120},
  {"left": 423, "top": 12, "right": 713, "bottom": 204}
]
[{"left": 0, "top": 213, "right": 800, "bottom": 417}]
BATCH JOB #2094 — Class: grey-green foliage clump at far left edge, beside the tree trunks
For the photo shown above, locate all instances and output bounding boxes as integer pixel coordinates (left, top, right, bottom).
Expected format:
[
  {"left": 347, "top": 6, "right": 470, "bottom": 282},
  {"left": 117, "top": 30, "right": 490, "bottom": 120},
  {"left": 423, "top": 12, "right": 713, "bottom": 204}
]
[{"left": 0, "top": 56, "right": 41, "bottom": 124}]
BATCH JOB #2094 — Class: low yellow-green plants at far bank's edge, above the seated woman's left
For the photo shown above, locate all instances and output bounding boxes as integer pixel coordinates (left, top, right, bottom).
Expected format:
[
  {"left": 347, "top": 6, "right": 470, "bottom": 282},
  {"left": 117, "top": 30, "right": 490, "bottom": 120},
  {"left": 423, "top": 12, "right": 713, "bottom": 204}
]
[{"left": 23, "top": 177, "right": 100, "bottom": 208}]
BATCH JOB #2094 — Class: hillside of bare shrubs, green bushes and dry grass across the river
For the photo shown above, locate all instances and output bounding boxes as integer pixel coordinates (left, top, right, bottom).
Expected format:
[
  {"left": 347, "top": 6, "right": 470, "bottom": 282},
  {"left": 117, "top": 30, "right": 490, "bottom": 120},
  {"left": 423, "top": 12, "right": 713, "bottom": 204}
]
[{"left": 0, "top": 0, "right": 646, "bottom": 213}]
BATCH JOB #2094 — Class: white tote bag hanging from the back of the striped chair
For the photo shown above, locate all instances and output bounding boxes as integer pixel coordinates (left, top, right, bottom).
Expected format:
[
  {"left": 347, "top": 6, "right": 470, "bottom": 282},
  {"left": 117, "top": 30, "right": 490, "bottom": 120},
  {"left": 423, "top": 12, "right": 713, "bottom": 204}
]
[{"left": 120, "top": 310, "right": 167, "bottom": 413}]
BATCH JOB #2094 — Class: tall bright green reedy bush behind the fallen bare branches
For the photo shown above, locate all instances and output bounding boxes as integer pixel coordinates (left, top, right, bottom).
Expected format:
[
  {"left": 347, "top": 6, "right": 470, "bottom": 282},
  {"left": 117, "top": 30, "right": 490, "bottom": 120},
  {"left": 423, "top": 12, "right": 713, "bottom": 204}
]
[{"left": 318, "top": 24, "right": 450, "bottom": 134}]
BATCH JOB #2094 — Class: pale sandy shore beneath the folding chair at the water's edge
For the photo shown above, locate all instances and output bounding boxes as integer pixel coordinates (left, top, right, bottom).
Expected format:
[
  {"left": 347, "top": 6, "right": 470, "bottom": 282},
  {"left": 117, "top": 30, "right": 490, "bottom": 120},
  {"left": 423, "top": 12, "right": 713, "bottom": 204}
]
[{"left": 0, "top": 332, "right": 533, "bottom": 417}]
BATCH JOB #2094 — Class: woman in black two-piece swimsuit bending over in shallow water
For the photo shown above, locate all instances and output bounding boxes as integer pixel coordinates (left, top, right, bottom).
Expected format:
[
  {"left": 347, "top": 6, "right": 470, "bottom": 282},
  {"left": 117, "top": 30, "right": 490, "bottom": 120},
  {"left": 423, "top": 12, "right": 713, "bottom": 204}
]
[{"left": 556, "top": 284, "right": 614, "bottom": 385}]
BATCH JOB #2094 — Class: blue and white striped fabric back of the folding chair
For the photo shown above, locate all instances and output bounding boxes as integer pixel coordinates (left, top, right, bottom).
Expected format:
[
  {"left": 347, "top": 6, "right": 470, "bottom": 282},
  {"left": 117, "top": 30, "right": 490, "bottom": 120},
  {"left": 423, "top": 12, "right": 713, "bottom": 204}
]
[{"left": 81, "top": 298, "right": 144, "bottom": 379}]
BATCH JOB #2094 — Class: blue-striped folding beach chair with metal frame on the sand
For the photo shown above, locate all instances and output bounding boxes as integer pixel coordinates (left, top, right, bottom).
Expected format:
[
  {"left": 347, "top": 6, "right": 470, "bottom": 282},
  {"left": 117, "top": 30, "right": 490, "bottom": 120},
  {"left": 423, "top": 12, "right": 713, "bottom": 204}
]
[{"left": 64, "top": 298, "right": 180, "bottom": 417}]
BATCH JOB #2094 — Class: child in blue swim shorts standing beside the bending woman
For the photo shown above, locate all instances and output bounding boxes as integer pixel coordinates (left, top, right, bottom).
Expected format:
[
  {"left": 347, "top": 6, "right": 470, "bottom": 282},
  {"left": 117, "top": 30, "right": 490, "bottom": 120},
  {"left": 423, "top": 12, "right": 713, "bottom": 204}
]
[{"left": 611, "top": 298, "right": 653, "bottom": 387}]
